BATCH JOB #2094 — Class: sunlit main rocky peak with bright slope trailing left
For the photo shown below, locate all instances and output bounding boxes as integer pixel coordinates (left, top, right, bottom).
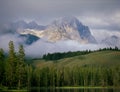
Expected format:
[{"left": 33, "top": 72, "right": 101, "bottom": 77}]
[{"left": 21, "top": 17, "right": 96, "bottom": 43}]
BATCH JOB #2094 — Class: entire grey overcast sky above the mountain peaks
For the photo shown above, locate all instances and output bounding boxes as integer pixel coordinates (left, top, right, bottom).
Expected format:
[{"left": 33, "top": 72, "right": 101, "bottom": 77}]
[{"left": 0, "top": 0, "right": 120, "bottom": 31}]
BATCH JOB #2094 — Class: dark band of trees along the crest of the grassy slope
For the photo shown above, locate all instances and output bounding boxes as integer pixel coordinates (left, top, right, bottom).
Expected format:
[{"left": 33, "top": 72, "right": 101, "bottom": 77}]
[{"left": 42, "top": 46, "right": 119, "bottom": 60}]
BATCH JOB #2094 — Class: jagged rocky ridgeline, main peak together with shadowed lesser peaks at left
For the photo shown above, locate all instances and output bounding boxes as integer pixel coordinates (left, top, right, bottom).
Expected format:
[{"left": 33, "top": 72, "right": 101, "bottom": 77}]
[{"left": 10, "top": 16, "right": 97, "bottom": 44}]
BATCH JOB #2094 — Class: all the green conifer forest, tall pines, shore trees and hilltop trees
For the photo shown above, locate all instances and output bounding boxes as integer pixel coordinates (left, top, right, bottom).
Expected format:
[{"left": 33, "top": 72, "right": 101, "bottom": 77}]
[{"left": 0, "top": 41, "right": 120, "bottom": 89}]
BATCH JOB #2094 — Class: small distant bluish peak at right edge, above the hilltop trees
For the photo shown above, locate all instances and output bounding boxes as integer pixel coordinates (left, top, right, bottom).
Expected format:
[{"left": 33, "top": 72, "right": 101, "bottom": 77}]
[{"left": 101, "top": 35, "right": 120, "bottom": 47}]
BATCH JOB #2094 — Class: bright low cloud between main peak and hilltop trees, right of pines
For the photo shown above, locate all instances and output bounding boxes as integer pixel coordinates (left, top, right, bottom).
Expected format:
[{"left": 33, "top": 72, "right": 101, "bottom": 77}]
[{"left": 25, "top": 40, "right": 105, "bottom": 57}]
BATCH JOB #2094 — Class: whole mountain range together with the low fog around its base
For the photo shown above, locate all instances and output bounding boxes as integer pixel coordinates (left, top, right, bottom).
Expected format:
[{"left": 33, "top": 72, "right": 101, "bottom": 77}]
[{"left": 0, "top": 16, "right": 120, "bottom": 58}]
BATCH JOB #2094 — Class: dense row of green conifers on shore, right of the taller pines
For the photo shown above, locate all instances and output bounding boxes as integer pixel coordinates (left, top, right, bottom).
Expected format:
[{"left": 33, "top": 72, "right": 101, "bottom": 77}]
[{"left": 31, "top": 66, "right": 120, "bottom": 87}]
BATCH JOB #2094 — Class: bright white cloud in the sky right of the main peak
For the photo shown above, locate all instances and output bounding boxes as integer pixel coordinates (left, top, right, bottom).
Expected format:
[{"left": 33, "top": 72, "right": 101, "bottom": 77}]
[{"left": 78, "top": 11, "right": 120, "bottom": 31}]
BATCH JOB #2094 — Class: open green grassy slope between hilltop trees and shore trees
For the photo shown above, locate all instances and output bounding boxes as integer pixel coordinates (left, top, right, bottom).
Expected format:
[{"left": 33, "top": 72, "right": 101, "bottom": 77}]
[{"left": 33, "top": 51, "right": 120, "bottom": 68}]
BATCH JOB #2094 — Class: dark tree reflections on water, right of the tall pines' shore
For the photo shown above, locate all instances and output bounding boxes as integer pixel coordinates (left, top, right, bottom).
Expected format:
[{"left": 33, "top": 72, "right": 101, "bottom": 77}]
[{"left": 30, "top": 88, "right": 120, "bottom": 92}]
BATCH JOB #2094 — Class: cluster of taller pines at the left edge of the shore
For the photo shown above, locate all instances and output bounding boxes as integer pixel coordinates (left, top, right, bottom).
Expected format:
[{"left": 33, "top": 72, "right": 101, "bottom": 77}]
[{"left": 0, "top": 41, "right": 29, "bottom": 89}]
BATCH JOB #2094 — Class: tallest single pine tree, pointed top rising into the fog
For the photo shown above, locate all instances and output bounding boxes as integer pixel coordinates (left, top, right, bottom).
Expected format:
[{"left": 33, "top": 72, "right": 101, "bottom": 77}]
[{"left": 5, "top": 41, "right": 17, "bottom": 87}]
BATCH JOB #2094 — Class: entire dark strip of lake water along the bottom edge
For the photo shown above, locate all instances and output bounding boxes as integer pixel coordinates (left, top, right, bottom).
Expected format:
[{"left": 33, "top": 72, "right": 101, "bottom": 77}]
[{"left": 0, "top": 88, "right": 120, "bottom": 92}]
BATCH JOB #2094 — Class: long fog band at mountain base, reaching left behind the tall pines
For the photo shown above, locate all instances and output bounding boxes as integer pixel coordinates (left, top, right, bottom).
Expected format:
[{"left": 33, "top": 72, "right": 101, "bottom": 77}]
[{"left": 0, "top": 34, "right": 118, "bottom": 58}]
